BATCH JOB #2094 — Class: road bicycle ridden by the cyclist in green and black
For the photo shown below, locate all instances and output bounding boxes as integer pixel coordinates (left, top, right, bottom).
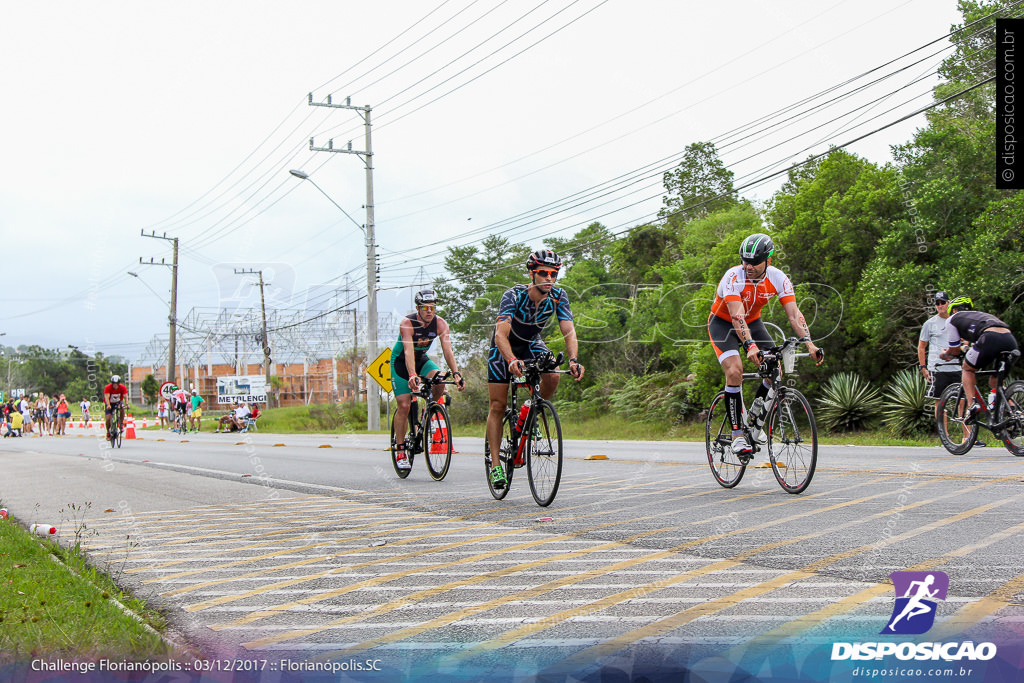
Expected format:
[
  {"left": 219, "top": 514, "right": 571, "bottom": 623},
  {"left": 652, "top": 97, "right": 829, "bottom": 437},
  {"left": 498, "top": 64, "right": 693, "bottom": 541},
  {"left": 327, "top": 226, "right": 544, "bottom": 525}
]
[{"left": 391, "top": 370, "right": 456, "bottom": 481}]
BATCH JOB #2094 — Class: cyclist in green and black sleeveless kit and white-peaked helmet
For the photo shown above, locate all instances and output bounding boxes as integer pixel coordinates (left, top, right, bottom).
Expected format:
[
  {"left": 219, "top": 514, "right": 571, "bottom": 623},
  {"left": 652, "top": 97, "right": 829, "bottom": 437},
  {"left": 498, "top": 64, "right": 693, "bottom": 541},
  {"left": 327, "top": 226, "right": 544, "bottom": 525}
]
[{"left": 391, "top": 289, "right": 466, "bottom": 469}]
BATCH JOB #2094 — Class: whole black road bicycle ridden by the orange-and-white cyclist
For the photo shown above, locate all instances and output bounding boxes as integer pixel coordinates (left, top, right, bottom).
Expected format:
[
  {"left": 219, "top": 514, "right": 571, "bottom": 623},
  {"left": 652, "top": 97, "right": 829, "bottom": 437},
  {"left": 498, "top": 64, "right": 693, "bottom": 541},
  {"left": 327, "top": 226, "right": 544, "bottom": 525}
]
[{"left": 705, "top": 337, "right": 818, "bottom": 494}]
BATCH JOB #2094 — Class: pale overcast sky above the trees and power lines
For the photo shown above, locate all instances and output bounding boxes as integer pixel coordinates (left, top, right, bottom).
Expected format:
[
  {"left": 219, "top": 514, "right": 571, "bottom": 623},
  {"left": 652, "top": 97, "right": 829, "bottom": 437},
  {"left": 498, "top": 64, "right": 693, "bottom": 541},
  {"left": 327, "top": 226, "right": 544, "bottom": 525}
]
[{"left": 0, "top": 0, "right": 959, "bottom": 359}]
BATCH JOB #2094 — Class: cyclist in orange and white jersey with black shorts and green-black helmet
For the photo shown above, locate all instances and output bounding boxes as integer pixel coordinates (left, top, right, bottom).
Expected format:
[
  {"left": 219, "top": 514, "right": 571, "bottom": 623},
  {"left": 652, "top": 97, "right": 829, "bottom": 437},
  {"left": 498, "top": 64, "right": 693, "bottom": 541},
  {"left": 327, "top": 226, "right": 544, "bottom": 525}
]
[{"left": 708, "top": 232, "right": 824, "bottom": 455}]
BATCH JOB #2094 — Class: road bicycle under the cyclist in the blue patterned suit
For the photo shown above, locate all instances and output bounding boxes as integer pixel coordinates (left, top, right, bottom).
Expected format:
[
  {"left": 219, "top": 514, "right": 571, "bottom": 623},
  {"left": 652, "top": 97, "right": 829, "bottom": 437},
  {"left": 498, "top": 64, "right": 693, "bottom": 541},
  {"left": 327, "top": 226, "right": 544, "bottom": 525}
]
[{"left": 483, "top": 353, "right": 568, "bottom": 508}]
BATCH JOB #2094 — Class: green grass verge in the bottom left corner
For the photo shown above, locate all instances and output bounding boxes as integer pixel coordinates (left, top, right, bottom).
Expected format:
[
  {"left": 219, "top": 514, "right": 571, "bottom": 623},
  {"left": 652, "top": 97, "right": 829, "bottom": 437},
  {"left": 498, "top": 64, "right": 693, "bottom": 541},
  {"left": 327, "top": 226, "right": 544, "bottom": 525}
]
[{"left": 0, "top": 511, "right": 173, "bottom": 663}]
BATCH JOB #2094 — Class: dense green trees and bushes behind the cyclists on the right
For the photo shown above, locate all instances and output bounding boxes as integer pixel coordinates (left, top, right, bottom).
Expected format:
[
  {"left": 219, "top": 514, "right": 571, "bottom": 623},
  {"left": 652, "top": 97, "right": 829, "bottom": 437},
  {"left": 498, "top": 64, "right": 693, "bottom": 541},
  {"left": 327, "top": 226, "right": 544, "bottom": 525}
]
[{"left": 436, "top": 0, "right": 1024, "bottom": 432}]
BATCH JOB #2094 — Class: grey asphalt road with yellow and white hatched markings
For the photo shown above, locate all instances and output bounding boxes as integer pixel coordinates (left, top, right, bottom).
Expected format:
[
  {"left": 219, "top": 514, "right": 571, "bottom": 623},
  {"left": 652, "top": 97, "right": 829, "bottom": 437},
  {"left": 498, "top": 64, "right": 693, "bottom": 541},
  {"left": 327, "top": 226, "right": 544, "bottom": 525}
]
[{"left": 0, "top": 430, "right": 1024, "bottom": 680}]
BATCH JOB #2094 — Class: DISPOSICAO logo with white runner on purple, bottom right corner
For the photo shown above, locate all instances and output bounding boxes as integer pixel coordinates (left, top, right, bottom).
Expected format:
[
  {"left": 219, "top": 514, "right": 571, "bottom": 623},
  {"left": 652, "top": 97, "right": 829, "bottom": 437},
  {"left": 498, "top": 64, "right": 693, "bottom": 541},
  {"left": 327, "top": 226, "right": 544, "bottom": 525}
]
[{"left": 831, "top": 571, "right": 996, "bottom": 661}]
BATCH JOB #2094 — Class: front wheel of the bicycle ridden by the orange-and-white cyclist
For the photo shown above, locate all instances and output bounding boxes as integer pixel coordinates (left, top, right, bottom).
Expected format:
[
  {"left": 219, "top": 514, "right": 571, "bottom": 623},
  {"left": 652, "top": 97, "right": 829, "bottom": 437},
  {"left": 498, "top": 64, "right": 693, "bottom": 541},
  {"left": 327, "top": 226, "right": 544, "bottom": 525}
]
[{"left": 765, "top": 389, "right": 818, "bottom": 494}]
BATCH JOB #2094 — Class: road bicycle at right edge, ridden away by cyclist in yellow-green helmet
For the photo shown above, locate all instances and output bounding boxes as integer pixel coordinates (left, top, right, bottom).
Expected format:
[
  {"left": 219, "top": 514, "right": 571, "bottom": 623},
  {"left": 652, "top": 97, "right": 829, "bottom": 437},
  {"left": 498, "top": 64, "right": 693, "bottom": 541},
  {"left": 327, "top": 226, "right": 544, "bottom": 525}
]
[{"left": 936, "top": 349, "right": 1024, "bottom": 457}]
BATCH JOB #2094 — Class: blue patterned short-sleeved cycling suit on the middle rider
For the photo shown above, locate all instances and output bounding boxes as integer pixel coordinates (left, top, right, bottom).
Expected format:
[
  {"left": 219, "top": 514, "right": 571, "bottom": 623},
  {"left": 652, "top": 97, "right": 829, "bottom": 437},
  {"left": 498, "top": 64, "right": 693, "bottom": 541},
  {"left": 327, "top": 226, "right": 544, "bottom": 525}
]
[{"left": 487, "top": 285, "right": 572, "bottom": 384}]
